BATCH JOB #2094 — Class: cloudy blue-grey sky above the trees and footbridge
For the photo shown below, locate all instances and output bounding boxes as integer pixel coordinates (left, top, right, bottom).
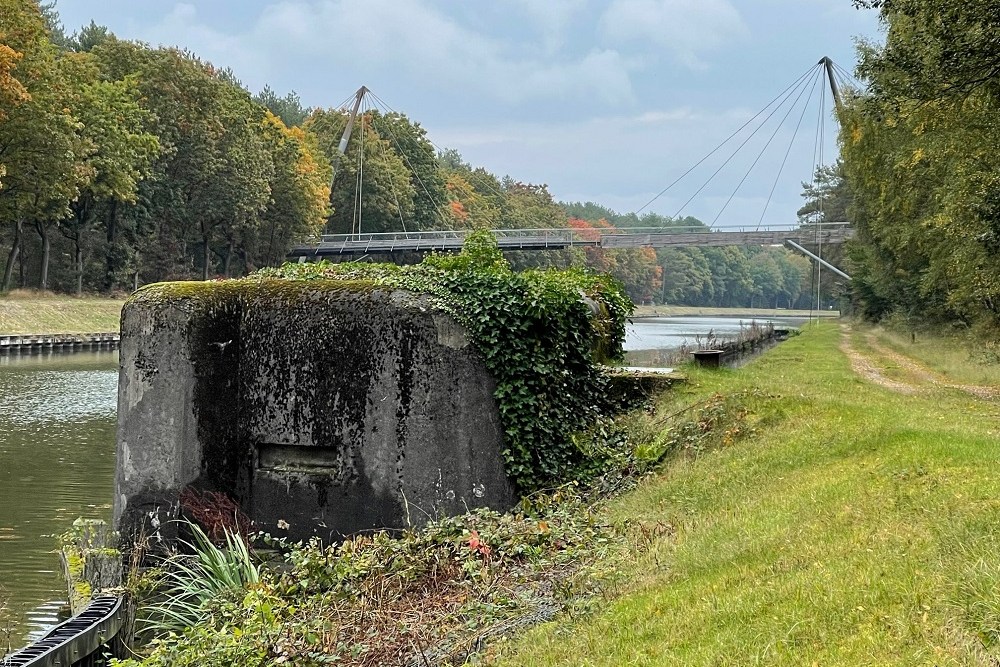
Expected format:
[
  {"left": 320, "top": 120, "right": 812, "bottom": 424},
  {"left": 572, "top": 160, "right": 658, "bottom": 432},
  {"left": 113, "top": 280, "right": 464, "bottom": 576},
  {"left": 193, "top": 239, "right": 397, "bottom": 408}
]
[{"left": 57, "top": 0, "right": 881, "bottom": 226}]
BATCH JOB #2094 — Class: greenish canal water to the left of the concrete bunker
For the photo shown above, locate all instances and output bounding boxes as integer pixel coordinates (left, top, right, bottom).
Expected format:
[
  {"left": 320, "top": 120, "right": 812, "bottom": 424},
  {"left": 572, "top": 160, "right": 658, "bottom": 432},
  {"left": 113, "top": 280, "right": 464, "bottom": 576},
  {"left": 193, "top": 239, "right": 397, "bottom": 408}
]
[{"left": 0, "top": 352, "right": 118, "bottom": 655}]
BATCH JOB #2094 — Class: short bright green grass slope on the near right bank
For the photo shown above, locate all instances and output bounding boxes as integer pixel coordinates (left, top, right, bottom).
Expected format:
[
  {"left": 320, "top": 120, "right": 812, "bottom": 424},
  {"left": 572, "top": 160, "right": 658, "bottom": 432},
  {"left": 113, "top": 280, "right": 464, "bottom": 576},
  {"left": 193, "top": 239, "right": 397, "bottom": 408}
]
[{"left": 502, "top": 324, "right": 1000, "bottom": 665}]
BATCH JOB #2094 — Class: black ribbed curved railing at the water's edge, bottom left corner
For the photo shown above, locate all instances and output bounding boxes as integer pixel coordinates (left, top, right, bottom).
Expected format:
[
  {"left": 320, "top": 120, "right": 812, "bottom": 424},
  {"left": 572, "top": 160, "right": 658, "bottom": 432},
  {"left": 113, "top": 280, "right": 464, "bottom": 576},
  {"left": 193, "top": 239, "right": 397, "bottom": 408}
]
[{"left": 0, "top": 596, "right": 125, "bottom": 667}]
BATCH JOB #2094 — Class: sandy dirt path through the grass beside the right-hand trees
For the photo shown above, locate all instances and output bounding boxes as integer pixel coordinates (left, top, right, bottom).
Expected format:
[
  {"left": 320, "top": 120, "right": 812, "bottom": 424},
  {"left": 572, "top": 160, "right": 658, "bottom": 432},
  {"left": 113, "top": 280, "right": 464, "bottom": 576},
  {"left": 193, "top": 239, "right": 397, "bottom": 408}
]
[{"left": 841, "top": 325, "right": 1000, "bottom": 399}]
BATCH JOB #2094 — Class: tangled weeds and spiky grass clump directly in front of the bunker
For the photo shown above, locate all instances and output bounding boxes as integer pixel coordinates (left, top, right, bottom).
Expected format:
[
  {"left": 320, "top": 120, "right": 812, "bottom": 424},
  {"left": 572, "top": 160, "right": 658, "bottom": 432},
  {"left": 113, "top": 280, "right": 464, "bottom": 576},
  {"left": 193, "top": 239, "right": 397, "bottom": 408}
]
[{"left": 119, "top": 494, "right": 624, "bottom": 666}]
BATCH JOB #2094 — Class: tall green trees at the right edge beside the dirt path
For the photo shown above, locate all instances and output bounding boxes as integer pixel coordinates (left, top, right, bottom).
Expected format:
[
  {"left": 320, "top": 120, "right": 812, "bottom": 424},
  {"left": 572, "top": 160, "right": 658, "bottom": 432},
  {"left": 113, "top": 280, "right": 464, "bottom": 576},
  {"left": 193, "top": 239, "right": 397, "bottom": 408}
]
[{"left": 840, "top": 0, "right": 1000, "bottom": 335}]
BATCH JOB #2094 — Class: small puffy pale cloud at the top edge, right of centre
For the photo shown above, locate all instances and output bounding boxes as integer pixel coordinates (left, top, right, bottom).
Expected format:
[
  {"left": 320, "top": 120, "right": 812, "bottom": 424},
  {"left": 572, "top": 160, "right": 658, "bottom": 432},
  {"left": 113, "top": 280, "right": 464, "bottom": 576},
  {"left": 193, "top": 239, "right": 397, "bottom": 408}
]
[{"left": 601, "top": 0, "right": 749, "bottom": 69}]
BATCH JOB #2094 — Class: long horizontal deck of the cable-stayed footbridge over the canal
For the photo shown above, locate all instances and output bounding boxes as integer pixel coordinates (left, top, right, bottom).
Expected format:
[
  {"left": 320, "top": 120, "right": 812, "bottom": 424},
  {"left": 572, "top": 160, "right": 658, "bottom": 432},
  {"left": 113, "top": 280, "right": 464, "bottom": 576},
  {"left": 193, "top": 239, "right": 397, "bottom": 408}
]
[{"left": 288, "top": 223, "right": 854, "bottom": 257}]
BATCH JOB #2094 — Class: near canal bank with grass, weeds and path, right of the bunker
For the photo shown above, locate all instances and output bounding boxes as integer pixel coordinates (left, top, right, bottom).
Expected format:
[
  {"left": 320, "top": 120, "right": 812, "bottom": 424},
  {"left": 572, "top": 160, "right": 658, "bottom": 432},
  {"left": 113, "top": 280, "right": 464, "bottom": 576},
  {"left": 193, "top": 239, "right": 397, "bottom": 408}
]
[{"left": 86, "top": 324, "right": 1000, "bottom": 666}]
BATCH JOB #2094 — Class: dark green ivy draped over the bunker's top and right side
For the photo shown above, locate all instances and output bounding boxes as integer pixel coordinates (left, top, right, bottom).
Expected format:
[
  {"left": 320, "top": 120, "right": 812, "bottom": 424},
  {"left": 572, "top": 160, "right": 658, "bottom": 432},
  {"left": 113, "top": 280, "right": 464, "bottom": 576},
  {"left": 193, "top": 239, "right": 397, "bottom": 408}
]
[{"left": 256, "top": 230, "right": 632, "bottom": 491}]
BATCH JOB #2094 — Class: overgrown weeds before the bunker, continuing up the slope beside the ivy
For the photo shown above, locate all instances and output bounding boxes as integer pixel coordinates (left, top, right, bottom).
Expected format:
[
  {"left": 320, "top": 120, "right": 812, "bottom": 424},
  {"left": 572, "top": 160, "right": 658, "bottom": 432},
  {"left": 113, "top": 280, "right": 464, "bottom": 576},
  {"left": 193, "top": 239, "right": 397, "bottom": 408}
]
[{"left": 118, "top": 374, "right": 766, "bottom": 667}]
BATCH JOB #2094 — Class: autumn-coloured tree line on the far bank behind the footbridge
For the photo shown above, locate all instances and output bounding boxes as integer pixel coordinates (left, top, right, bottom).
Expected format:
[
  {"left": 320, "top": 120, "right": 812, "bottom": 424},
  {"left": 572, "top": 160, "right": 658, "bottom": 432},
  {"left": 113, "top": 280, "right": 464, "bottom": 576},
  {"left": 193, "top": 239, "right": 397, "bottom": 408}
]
[{"left": 0, "top": 0, "right": 832, "bottom": 307}]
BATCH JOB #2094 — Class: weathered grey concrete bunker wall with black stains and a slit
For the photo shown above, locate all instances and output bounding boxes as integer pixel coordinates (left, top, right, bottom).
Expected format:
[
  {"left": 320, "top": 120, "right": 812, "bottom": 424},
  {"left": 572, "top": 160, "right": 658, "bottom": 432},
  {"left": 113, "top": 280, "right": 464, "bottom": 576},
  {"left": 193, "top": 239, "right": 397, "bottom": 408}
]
[{"left": 115, "top": 280, "right": 514, "bottom": 538}]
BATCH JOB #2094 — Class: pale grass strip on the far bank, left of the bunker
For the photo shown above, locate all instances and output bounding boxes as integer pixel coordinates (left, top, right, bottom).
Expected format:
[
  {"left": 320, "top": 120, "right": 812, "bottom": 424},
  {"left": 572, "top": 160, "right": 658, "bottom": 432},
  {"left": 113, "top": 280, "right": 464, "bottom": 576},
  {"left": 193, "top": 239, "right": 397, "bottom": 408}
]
[{"left": 0, "top": 292, "right": 125, "bottom": 334}]
